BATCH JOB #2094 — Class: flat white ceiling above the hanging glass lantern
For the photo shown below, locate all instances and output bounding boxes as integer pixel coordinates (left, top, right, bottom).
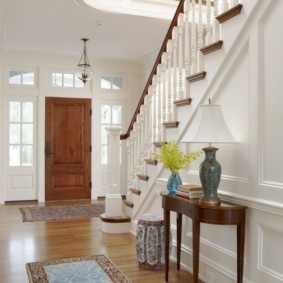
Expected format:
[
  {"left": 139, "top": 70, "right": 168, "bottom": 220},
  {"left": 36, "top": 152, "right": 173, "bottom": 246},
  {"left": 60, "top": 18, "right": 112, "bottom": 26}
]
[{"left": 0, "top": 0, "right": 178, "bottom": 60}]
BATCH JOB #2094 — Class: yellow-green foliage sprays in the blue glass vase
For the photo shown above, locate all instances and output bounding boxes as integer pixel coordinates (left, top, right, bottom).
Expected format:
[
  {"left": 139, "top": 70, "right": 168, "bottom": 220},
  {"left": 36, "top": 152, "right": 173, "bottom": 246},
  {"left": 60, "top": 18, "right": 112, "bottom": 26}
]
[{"left": 153, "top": 140, "right": 202, "bottom": 175}]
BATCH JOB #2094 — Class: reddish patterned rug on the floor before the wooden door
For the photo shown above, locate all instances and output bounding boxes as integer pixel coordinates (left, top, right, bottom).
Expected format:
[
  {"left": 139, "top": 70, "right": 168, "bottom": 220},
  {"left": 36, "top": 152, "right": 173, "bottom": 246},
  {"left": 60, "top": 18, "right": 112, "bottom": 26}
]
[{"left": 19, "top": 203, "right": 105, "bottom": 222}]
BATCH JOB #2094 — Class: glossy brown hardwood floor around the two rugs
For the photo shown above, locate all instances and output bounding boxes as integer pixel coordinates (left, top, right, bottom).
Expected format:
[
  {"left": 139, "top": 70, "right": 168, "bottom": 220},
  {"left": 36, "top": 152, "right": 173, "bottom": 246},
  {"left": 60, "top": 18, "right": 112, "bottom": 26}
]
[{"left": 0, "top": 201, "right": 202, "bottom": 283}]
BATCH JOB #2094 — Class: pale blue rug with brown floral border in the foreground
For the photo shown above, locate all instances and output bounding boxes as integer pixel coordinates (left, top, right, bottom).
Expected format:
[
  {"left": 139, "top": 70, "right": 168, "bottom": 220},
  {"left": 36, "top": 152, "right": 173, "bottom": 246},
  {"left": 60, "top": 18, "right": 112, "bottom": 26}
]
[{"left": 26, "top": 255, "right": 131, "bottom": 283}]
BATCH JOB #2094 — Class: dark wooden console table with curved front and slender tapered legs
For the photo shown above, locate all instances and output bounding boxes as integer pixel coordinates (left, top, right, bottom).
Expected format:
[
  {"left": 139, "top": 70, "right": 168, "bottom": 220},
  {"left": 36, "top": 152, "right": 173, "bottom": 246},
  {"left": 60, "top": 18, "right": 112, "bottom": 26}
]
[{"left": 161, "top": 193, "right": 247, "bottom": 283}]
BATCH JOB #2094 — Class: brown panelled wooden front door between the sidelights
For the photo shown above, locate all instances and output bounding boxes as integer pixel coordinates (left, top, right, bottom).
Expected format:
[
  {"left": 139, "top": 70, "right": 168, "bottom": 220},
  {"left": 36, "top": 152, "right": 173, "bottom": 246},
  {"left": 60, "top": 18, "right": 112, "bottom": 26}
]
[{"left": 45, "top": 97, "right": 91, "bottom": 200}]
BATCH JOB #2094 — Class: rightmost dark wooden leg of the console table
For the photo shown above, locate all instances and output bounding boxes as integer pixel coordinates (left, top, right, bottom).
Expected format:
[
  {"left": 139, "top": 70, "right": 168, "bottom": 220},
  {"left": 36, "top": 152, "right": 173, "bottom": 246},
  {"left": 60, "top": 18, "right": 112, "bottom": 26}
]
[{"left": 237, "top": 221, "right": 245, "bottom": 283}]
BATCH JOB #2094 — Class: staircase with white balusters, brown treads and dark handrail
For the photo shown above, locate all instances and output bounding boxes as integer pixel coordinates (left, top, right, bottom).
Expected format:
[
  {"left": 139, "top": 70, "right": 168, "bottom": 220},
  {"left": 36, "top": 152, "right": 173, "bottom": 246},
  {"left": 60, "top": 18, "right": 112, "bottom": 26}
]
[{"left": 121, "top": 0, "right": 252, "bottom": 231}]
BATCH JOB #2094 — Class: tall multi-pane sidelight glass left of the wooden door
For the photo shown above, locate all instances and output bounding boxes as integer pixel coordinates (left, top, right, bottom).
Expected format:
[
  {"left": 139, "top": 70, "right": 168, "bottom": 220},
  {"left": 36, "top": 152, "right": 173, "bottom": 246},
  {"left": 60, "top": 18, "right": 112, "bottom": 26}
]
[{"left": 9, "top": 101, "right": 34, "bottom": 166}]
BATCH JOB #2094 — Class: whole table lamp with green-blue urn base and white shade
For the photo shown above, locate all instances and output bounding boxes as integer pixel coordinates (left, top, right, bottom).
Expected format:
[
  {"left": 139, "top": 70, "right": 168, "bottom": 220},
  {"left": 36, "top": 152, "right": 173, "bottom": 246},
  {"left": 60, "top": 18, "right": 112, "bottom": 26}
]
[{"left": 182, "top": 100, "right": 236, "bottom": 205}]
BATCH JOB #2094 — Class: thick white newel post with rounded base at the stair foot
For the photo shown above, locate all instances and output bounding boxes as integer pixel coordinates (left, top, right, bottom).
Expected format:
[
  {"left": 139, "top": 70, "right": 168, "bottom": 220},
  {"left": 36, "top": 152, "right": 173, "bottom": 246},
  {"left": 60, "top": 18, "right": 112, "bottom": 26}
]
[{"left": 100, "top": 126, "right": 130, "bottom": 233}]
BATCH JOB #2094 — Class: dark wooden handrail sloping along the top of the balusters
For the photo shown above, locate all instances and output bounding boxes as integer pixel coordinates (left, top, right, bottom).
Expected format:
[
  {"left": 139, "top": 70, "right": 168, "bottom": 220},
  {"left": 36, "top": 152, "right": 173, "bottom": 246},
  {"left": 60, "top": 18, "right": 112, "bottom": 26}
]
[{"left": 120, "top": 0, "right": 185, "bottom": 140}]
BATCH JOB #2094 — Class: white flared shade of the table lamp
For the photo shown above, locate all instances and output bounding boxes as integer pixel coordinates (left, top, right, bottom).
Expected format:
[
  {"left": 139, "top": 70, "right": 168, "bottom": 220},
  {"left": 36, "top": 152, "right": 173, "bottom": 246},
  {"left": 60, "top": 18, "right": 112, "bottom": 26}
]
[{"left": 186, "top": 104, "right": 236, "bottom": 143}]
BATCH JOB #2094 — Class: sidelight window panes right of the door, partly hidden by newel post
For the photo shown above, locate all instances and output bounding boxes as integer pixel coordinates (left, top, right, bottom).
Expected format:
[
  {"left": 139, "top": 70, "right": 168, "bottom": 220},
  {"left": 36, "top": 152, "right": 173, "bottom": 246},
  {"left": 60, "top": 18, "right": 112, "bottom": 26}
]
[{"left": 101, "top": 105, "right": 122, "bottom": 165}]
